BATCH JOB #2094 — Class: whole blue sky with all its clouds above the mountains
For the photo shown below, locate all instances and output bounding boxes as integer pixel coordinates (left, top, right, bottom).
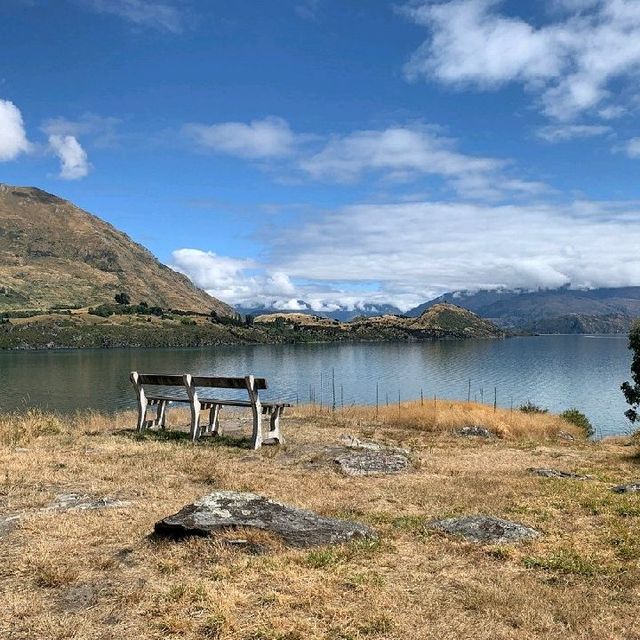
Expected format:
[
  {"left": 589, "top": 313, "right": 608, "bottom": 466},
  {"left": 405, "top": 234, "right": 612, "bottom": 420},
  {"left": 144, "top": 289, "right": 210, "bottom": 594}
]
[{"left": 0, "top": 0, "right": 640, "bottom": 310}]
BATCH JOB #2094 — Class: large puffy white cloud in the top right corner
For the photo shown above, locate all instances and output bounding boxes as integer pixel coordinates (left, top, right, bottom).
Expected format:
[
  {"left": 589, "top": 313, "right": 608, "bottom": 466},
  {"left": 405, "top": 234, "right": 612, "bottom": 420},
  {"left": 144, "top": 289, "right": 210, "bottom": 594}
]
[{"left": 404, "top": 0, "right": 640, "bottom": 120}]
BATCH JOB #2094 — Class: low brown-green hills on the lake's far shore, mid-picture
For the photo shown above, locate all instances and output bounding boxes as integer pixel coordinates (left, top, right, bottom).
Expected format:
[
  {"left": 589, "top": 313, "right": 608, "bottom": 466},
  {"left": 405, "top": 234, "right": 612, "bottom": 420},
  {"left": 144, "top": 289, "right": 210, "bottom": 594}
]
[{"left": 254, "top": 303, "right": 506, "bottom": 341}]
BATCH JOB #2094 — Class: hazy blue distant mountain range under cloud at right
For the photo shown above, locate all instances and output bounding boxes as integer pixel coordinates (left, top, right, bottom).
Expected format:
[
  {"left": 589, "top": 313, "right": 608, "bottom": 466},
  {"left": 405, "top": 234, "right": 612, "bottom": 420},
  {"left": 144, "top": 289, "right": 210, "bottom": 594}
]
[{"left": 407, "top": 287, "right": 640, "bottom": 333}]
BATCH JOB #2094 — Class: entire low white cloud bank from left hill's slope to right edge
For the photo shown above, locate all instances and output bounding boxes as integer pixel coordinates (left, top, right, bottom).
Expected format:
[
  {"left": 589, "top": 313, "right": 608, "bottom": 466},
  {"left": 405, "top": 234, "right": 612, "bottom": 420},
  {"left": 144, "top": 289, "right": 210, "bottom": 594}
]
[{"left": 174, "top": 201, "right": 640, "bottom": 311}]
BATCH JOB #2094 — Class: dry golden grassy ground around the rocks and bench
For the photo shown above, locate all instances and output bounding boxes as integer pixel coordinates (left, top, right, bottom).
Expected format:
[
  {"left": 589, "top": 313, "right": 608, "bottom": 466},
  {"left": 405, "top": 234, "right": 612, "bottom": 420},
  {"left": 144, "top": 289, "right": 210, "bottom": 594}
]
[{"left": 0, "top": 402, "right": 640, "bottom": 640}]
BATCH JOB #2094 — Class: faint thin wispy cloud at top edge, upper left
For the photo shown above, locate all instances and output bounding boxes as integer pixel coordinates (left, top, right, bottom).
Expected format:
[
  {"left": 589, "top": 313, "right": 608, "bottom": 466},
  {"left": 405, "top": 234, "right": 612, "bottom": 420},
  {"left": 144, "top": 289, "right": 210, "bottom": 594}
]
[{"left": 80, "top": 0, "right": 186, "bottom": 33}]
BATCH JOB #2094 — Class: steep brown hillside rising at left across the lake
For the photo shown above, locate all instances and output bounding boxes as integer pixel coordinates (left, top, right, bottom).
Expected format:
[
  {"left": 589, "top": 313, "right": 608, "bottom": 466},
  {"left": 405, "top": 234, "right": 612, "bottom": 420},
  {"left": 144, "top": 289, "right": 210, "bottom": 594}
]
[{"left": 0, "top": 184, "right": 235, "bottom": 317}]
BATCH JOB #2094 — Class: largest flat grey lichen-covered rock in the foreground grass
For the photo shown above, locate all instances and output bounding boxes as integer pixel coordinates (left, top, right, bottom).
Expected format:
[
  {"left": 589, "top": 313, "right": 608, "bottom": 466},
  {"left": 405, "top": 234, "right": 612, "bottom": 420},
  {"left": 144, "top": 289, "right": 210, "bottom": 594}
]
[{"left": 155, "top": 491, "right": 377, "bottom": 547}]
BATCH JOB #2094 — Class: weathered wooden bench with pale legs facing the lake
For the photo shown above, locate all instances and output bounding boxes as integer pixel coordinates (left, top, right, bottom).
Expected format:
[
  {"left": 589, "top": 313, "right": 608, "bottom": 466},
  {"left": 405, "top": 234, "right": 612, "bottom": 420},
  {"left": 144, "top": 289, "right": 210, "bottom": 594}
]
[{"left": 129, "top": 371, "right": 291, "bottom": 449}]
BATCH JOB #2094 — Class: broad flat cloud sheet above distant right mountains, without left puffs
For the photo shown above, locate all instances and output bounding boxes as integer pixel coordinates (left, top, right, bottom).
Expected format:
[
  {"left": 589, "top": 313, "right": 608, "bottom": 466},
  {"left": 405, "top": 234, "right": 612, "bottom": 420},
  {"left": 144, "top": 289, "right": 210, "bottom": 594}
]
[{"left": 270, "top": 202, "right": 640, "bottom": 299}]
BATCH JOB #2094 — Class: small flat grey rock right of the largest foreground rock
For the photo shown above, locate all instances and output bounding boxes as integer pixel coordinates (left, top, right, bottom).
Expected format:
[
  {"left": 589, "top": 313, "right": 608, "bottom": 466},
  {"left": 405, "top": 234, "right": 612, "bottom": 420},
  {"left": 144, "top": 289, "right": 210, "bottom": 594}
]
[{"left": 429, "top": 516, "right": 540, "bottom": 544}]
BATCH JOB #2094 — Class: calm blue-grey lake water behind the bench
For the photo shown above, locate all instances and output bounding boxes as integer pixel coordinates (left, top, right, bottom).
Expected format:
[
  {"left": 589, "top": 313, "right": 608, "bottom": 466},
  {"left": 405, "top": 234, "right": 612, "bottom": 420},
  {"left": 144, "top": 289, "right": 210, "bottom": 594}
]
[{"left": 0, "top": 336, "right": 631, "bottom": 436}]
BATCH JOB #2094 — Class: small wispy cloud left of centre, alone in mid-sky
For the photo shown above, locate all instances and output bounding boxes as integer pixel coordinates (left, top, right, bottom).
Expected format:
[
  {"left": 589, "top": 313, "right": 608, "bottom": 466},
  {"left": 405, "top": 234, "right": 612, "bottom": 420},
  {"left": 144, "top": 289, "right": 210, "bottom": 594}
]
[{"left": 183, "top": 117, "right": 296, "bottom": 160}]
